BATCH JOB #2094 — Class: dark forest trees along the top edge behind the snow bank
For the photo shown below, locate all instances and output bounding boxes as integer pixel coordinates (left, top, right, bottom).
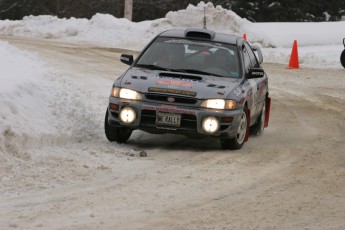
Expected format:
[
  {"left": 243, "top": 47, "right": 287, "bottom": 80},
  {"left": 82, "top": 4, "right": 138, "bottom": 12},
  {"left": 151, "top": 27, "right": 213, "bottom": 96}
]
[{"left": 0, "top": 0, "right": 345, "bottom": 22}]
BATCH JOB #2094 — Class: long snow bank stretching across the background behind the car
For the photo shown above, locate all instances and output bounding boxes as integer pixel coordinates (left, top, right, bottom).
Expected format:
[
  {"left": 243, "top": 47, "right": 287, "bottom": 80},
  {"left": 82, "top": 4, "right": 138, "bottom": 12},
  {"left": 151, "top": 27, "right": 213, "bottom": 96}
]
[{"left": 0, "top": 2, "right": 345, "bottom": 49}]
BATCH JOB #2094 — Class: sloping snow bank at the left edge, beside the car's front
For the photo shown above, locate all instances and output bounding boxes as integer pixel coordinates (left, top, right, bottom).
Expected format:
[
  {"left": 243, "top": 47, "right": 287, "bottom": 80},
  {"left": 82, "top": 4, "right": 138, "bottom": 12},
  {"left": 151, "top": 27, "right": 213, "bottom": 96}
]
[{"left": 0, "top": 41, "right": 102, "bottom": 160}]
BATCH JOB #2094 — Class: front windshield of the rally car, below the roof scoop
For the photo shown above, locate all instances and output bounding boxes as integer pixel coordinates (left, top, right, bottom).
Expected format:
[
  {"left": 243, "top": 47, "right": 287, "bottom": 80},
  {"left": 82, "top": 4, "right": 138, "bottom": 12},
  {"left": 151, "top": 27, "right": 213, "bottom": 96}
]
[{"left": 135, "top": 37, "right": 240, "bottom": 78}]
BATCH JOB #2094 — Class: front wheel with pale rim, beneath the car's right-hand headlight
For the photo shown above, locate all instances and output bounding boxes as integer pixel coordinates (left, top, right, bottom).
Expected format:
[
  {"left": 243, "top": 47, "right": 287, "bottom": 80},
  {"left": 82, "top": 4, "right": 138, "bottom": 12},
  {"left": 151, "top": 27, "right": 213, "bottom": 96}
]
[{"left": 220, "top": 107, "right": 249, "bottom": 150}]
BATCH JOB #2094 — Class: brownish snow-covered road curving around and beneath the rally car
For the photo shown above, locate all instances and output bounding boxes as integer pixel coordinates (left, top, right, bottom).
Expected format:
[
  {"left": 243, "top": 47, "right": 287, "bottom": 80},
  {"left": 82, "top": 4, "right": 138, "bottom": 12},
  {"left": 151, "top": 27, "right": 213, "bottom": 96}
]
[{"left": 0, "top": 36, "right": 345, "bottom": 229}]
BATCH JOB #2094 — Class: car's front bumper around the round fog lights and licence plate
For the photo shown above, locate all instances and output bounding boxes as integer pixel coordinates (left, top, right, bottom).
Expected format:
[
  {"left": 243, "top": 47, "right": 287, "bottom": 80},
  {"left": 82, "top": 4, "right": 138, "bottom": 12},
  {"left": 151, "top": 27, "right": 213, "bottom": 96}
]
[{"left": 108, "top": 97, "right": 243, "bottom": 138}]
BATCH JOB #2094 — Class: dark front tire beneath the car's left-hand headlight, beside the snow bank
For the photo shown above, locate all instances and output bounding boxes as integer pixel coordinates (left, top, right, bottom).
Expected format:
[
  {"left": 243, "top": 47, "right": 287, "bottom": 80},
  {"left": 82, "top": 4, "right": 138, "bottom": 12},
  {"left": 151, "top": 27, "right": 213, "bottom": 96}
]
[{"left": 104, "top": 109, "right": 132, "bottom": 144}]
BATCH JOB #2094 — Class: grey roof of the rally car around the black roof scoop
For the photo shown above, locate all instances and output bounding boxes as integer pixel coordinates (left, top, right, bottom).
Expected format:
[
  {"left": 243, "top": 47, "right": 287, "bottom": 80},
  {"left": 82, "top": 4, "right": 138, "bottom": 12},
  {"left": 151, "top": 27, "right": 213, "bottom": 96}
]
[{"left": 158, "top": 28, "right": 243, "bottom": 45}]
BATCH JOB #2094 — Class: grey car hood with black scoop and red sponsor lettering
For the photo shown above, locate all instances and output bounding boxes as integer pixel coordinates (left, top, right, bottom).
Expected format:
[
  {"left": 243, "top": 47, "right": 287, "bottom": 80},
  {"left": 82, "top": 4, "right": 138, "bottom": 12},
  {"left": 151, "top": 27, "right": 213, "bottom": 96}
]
[{"left": 120, "top": 67, "right": 241, "bottom": 99}]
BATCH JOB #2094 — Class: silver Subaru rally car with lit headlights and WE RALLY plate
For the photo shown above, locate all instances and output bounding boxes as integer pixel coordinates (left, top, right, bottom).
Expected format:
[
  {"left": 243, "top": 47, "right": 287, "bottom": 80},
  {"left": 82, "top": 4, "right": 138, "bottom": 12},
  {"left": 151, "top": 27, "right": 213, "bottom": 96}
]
[{"left": 104, "top": 29, "right": 271, "bottom": 149}]
